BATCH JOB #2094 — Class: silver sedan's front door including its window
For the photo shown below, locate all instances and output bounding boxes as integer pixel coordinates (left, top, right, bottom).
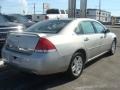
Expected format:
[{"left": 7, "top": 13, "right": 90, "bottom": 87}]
[{"left": 92, "top": 22, "right": 110, "bottom": 53}]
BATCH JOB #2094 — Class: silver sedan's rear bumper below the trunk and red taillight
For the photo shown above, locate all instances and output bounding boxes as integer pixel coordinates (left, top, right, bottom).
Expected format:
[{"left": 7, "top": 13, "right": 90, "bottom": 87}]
[{"left": 2, "top": 49, "right": 69, "bottom": 75}]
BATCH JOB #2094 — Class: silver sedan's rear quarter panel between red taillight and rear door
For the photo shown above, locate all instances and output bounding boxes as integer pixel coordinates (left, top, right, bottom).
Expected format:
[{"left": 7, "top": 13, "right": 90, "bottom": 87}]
[{"left": 48, "top": 35, "right": 85, "bottom": 67}]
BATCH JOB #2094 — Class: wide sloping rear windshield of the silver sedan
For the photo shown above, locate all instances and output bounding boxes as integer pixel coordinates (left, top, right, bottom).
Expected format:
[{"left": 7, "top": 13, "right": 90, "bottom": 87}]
[{"left": 26, "top": 20, "right": 71, "bottom": 34}]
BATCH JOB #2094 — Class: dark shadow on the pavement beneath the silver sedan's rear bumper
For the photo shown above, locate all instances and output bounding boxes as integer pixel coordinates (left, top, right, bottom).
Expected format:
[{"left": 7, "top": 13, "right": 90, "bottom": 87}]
[{"left": 0, "top": 65, "right": 72, "bottom": 90}]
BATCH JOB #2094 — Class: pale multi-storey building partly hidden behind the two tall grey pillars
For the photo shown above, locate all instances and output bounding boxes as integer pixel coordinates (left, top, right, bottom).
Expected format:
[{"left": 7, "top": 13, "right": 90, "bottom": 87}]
[{"left": 76, "top": 9, "right": 111, "bottom": 22}]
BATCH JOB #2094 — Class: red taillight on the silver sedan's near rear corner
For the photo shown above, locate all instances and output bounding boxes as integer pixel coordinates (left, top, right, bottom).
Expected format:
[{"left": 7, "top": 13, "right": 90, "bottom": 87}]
[{"left": 35, "top": 38, "right": 56, "bottom": 52}]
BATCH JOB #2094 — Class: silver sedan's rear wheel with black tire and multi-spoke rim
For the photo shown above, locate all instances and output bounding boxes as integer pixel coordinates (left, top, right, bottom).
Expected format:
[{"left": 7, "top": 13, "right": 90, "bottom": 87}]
[{"left": 67, "top": 53, "right": 84, "bottom": 79}]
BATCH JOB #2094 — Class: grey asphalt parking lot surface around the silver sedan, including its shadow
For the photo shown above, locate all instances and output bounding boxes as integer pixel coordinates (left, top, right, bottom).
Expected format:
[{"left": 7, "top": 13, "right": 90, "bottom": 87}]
[{"left": 0, "top": 27, "right": 120, "bottom": 90}]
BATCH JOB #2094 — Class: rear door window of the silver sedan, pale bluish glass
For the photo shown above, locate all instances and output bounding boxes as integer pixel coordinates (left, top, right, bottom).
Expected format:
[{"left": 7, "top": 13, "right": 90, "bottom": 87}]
[{"left": 81, "top": 21, "right": 95, "bottom": 34}]
